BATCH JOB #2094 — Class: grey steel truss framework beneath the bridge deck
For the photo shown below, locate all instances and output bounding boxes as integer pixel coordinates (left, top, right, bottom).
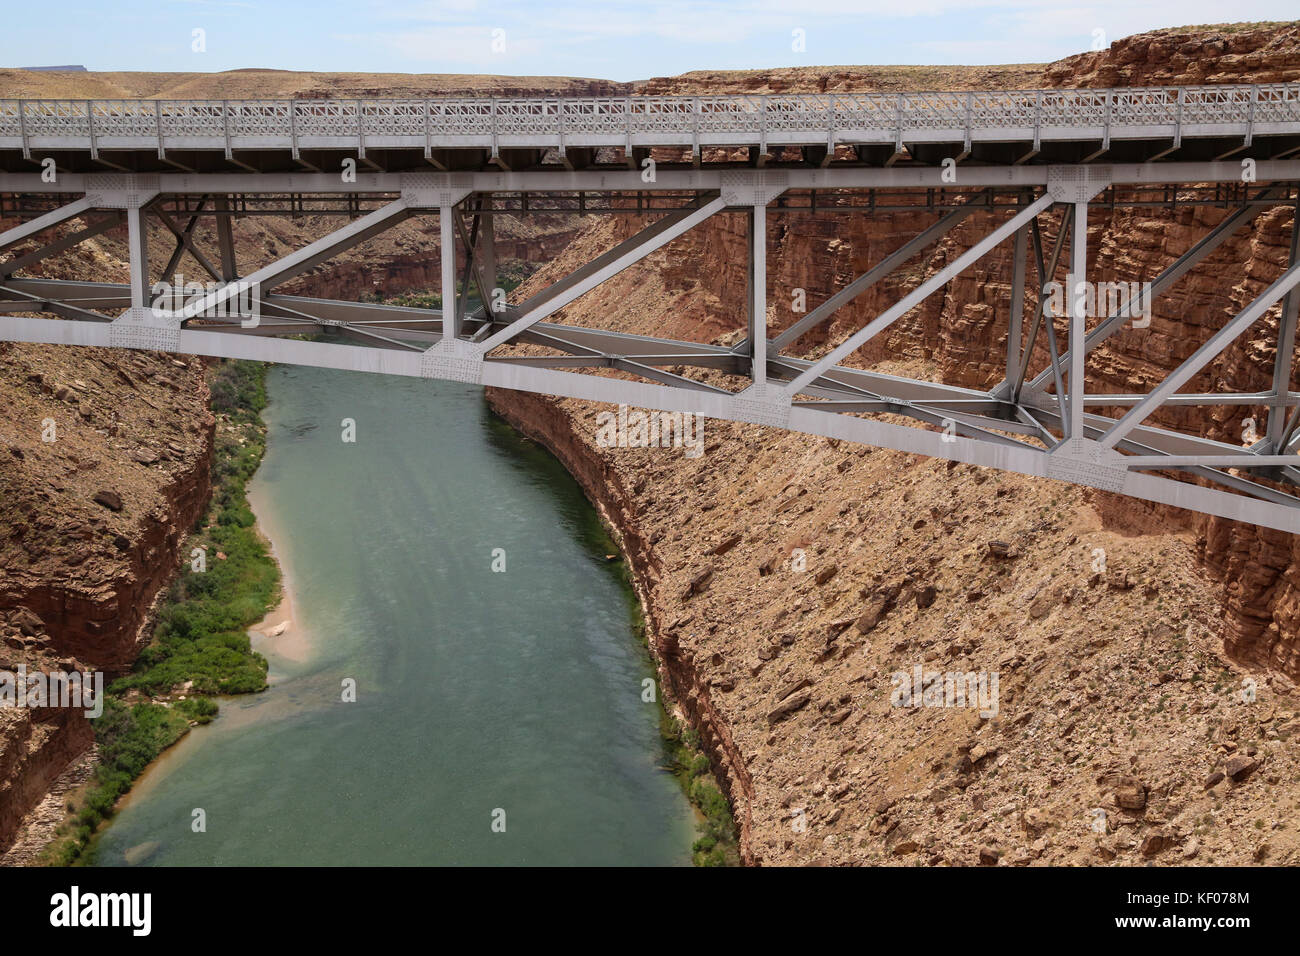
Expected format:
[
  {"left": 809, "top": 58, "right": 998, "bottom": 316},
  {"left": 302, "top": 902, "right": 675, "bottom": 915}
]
[{"left": 0, "top": 166, "right": 1300, "bottom": 532}]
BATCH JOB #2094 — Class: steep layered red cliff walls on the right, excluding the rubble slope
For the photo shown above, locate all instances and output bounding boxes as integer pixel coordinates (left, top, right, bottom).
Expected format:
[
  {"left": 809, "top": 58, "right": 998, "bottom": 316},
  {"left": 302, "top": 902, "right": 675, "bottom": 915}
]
[{"left": 553, "top": 23, "right": 1300, "bottom": 679}]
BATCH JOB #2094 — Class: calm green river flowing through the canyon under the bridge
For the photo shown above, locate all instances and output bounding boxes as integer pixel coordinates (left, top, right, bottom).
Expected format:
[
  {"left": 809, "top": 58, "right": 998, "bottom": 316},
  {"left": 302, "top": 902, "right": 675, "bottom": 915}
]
[{"left": 89, "top": 367, "right": 694, "bottom": 865}]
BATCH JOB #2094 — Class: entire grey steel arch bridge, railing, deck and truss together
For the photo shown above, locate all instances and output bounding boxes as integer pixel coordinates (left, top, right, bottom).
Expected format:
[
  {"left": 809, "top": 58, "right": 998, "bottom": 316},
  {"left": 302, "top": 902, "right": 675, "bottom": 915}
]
[{"left": 0, "top": 85, "right": 1300, "bottom": 532}]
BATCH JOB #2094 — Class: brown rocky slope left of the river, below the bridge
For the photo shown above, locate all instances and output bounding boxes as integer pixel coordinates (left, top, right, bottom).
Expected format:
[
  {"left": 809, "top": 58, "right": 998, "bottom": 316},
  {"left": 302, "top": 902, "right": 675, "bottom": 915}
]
[{"left": 0, "top": 293, "right": 212, "bottom": 848}]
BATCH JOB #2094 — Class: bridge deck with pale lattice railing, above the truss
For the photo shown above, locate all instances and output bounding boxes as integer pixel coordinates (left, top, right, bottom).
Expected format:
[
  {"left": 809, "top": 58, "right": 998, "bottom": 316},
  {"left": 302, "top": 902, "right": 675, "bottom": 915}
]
[{"left": 0, "top": 83, "right": 1300, "bottom": 170}]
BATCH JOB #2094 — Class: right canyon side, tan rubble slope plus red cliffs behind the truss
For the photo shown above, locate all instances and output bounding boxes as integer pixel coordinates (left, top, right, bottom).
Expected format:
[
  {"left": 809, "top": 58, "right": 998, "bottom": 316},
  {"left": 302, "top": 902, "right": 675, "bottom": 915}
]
[{"left": 491, "top": 27, "right": 1300, "bottom": 864}]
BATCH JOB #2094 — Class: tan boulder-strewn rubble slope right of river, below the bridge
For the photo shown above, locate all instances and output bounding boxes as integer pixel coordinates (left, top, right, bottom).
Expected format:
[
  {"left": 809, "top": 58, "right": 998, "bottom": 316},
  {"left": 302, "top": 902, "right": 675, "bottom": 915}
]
[{"left": 491, "top": 393, "right": 1300, "bottom": 865}]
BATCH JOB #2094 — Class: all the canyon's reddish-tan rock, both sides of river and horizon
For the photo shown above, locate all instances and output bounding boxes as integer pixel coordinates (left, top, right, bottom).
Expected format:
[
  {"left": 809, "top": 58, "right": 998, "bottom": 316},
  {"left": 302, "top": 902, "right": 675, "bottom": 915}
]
[{"left": 0, "top": 25, "right": 1300, "bottom": 865}]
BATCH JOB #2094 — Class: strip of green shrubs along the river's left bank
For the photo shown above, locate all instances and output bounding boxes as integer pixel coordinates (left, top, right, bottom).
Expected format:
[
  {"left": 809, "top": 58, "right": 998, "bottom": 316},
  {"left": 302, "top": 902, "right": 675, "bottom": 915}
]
[{"left": 25, "top": 363, "right": 280, "bottom": 866}]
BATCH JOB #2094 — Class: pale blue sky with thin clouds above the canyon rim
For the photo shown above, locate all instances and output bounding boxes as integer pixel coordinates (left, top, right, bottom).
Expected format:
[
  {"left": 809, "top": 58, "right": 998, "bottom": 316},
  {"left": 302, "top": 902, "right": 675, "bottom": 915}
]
[{"left": 0, "top": 0, "right": 1300, "bottom": 81}]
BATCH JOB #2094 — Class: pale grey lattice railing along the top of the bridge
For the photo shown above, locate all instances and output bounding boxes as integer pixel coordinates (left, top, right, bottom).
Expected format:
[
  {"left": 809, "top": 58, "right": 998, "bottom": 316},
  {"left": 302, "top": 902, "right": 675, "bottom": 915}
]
[{"left": 0, "top": 83, "right": 1300, "bottom": 148}]
